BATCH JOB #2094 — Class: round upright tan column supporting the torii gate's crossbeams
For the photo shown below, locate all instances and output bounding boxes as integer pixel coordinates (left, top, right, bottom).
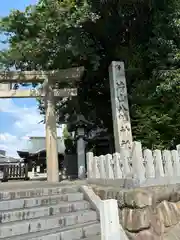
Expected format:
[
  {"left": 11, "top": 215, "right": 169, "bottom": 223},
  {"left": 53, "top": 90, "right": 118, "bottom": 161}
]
[{"left": 45, "top": 82, "right": 59, "bottom": 182}]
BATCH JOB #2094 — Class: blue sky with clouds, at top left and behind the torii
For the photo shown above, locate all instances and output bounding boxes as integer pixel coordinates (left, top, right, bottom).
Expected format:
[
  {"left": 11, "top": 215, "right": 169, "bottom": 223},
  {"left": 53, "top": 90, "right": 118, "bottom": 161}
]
[{"left": 0, "top": 0, "right": 61, "bottom": 157}]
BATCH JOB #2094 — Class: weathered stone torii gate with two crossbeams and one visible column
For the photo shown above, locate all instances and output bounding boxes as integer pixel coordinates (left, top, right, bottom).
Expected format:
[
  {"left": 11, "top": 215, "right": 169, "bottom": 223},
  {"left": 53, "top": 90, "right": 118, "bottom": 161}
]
[{"left": 0, "top": 67, "right": 84, "bottom": 182}]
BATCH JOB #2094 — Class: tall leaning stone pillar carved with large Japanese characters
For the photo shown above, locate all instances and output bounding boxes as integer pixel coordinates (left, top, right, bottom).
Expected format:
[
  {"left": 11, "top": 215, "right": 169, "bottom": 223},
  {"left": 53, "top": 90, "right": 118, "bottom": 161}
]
[{"left": 109, "top": 61, "right": 132, "bottom": 152}]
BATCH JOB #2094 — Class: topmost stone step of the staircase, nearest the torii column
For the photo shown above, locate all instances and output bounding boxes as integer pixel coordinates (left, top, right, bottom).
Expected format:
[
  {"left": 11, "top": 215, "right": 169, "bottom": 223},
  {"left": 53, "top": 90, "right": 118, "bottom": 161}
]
[{"left": 0, "top": 185, "right": 79, "bottom": 201}]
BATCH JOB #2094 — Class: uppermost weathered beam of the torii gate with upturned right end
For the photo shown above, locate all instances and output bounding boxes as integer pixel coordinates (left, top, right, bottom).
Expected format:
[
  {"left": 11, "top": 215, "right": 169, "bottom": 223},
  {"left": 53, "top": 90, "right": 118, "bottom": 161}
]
[{"left": 0, "top": 67, "right": 84, "bottom": 83}]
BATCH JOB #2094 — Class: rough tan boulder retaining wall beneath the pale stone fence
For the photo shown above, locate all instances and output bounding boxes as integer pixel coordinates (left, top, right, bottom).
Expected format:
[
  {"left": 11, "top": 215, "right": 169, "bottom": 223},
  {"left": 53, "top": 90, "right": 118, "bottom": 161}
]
[{"left": 93, "top": 184, "right": 180, "bottom": 240}]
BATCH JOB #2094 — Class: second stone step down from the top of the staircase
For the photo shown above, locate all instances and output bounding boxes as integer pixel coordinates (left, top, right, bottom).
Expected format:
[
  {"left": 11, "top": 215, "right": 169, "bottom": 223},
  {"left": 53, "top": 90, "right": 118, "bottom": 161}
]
[{"left": 0, "top": 192, "right": 84, "bottom": 211}]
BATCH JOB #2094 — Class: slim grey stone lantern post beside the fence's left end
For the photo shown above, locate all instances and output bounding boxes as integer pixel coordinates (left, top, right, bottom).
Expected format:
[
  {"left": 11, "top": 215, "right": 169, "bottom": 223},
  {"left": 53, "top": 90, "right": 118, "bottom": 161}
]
[{"left": 77, "top": 128, "right": 86, "bottom": 179}]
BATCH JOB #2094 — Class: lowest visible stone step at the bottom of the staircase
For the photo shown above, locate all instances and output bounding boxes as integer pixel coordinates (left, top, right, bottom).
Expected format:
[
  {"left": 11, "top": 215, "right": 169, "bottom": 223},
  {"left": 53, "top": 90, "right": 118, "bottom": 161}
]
[{"left": 3, "top": 221, "right": 100, "bottom": 240}]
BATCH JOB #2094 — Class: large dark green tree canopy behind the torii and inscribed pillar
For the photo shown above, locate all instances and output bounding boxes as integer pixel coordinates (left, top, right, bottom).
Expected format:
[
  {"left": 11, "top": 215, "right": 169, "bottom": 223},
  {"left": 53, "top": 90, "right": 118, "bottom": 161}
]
[{"left": 0, "top": 0, "right": 180, "bottom": 148}]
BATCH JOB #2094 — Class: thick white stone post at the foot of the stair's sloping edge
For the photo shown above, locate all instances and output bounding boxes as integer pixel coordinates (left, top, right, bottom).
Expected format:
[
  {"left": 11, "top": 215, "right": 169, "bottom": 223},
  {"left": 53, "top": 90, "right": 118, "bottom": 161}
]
[{"left": 100, "top": 199, "right": 121, "bottom": 240}]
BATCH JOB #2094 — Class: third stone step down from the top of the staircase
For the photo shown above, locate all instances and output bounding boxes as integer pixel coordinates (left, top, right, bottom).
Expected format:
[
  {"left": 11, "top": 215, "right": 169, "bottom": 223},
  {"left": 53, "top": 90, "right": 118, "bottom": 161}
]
[{"left": 0, "top": 201, "right": 90, "bottom": 223}]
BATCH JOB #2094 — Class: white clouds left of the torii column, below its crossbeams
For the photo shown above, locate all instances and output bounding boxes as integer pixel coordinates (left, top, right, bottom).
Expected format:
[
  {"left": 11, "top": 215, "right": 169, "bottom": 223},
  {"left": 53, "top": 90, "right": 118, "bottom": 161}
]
[{"left": 0, "top": 99, "right": 62, "bottom": 157}]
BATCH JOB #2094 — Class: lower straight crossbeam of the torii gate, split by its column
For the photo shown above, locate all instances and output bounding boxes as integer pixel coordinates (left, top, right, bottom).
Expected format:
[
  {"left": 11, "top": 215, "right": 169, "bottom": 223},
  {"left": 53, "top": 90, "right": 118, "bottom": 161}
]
[{"left": 0, "top": 88, "right": 77, "bottom": 98}]
